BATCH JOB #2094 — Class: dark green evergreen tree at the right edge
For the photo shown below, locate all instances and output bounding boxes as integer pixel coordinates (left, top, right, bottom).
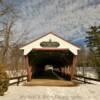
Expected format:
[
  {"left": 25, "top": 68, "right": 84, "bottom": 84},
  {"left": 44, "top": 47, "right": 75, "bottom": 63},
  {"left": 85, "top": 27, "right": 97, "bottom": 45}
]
[{"left": 86, "top": 26, "right": 100, "bottom": 66}]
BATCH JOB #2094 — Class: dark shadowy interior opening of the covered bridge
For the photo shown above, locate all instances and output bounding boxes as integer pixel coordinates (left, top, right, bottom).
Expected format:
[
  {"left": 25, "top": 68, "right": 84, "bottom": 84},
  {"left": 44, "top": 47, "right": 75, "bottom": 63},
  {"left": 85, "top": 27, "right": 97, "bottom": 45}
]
[{"left": 28, "top": 50, "right": 73, "bottom": 78}]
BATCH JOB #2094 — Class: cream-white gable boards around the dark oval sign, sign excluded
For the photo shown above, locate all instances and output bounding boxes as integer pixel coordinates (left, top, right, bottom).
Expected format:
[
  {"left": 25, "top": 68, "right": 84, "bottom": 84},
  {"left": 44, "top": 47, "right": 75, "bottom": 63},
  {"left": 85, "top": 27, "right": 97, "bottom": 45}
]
[{"left": 20, "top": 32, "right": 80, "bottom": 55}]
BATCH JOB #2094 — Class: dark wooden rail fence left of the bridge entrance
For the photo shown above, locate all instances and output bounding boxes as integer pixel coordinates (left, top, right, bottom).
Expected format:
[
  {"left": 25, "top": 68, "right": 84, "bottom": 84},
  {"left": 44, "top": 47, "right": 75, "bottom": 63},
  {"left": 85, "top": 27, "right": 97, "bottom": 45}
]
[{"left": 9, "top": 75, "right": 27, "bottom": 86}]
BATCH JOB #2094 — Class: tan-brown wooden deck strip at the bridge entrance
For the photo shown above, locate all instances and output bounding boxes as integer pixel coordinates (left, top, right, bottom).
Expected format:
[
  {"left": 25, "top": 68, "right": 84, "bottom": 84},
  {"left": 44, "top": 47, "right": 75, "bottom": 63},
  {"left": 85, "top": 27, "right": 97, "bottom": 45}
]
[{"left": 24, "top": 79, "right": 79, "bottom": 86}]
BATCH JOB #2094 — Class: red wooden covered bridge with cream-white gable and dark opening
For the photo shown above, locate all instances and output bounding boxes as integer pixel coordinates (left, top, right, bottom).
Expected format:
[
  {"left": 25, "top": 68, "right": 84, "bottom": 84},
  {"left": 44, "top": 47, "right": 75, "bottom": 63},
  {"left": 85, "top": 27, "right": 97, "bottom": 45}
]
[{"left": 20, "top": 32, "right": 80, "bottom": 81}]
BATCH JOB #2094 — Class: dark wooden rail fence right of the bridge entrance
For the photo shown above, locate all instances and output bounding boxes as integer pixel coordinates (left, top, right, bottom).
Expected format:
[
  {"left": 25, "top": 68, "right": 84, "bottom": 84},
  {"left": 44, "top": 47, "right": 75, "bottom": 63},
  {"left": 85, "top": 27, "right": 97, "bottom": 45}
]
[{"left": 75, "top": 75, "right": 100, "bottom": 84}]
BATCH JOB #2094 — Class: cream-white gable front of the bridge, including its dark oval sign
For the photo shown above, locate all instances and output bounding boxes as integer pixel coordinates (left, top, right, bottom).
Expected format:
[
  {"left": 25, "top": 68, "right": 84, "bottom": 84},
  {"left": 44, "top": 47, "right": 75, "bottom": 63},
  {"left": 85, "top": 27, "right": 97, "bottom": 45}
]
[{"left": 20, "top": 32, "right": 80, "bottom": 55}]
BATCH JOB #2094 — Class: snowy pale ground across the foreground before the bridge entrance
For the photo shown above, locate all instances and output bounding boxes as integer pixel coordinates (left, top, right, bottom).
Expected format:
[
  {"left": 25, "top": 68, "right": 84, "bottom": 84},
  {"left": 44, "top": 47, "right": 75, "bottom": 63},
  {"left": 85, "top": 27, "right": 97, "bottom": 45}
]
[{"left": 0, "top": 84, "right": 100, "bottom": 100}]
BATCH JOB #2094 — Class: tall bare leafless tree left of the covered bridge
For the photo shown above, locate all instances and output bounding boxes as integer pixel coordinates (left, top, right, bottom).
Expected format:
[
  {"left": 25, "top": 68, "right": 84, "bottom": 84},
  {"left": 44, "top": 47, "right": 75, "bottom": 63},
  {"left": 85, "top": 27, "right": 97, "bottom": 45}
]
[{"left": 0, "top": 0, "right": 31, "bottom": 75}]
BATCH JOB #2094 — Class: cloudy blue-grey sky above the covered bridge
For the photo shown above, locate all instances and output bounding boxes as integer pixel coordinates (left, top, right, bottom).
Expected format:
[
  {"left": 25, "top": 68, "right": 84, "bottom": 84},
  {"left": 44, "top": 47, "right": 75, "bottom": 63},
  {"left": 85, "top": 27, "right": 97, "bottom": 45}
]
[{"left": 2, "top": 0, "right": 100, "bottom": 40}]
